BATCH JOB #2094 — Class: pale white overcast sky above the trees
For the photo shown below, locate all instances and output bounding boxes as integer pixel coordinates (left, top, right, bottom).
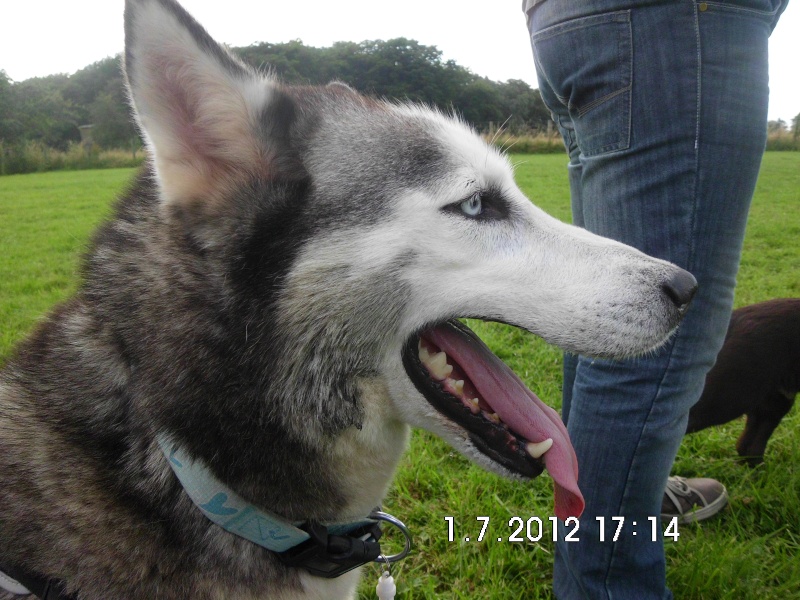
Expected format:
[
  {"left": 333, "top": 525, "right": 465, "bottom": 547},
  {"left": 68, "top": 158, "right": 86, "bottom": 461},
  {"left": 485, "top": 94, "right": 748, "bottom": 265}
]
[{"left": 0, "top": 0, "right": 800, "bottom": 122}]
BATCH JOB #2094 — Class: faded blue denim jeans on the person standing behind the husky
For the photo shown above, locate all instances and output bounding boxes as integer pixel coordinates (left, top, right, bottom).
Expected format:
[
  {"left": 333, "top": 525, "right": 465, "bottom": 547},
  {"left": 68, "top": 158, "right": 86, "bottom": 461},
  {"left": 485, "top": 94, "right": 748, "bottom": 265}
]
[{"left": 528, "top": 0, "right": 780, "bottom": 600}]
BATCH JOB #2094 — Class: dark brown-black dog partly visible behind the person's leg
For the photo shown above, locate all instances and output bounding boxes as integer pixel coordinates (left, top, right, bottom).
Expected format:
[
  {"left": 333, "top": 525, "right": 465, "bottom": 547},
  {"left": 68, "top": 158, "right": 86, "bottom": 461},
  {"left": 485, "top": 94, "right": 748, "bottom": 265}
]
[{"left": 686, "top": 298, "right": 800, "bottom": 466}]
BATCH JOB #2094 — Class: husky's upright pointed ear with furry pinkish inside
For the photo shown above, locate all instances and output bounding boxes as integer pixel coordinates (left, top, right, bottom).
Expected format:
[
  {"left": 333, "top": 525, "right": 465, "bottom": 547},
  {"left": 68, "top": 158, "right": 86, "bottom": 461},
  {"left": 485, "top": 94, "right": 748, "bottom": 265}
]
[{"left": 125, "top": 0, "right": 275, "bottom": 204}]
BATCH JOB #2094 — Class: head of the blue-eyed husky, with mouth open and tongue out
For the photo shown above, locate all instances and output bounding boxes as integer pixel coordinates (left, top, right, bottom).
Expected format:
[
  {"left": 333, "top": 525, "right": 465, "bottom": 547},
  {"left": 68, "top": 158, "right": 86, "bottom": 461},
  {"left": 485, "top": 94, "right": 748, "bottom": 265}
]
[{"left": 125, "top": 0, "right": 695, "bottom": 517}]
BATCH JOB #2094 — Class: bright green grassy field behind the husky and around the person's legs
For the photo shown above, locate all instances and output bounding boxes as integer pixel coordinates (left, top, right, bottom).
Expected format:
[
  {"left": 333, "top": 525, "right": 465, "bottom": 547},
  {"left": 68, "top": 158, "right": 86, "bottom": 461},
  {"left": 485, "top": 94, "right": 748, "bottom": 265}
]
[{"left": 0, "top": 152, "right": 800, "bottom": 600}]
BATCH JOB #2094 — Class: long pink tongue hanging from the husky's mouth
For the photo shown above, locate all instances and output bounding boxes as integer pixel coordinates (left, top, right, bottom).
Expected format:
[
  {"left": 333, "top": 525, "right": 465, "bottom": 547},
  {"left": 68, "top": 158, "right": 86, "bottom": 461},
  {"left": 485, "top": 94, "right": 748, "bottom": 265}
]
[{"left": 424, "top": 323, "right": 584, "bottom": 520}]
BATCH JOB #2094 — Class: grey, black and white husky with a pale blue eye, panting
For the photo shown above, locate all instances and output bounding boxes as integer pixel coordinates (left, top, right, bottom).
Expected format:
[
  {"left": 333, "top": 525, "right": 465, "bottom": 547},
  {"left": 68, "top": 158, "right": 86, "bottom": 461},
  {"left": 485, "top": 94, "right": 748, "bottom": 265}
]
[{"left": 0, "top": 0, "right": 696, "bottom": 600}]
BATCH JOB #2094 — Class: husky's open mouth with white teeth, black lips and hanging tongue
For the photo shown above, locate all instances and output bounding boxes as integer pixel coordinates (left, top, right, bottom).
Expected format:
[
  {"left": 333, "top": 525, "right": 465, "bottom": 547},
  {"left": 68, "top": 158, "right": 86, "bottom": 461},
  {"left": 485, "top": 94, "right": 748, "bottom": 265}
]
[{"left": 403, "top": 320, "right": 584, "bottom": 519}]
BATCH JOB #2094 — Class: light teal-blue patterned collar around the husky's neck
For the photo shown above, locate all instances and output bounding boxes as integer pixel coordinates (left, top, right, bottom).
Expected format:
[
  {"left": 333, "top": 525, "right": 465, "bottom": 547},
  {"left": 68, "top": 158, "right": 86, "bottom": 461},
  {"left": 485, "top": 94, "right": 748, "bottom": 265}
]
[{"left": 158, "top": 435, "right": 374, "bottom": 552}]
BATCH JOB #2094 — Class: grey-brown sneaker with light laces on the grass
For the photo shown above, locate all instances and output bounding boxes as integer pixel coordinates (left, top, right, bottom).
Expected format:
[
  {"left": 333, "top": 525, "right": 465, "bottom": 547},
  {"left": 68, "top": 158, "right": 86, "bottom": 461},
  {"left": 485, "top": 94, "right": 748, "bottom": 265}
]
[{"left": 661, "top": 477, "right": 728, "bottom": 525}]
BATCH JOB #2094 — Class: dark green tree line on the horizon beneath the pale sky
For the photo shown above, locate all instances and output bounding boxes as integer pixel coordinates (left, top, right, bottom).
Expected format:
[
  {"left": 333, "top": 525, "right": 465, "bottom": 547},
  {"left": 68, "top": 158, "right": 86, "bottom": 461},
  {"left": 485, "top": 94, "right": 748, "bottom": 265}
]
[{"left": 0, "top": 38, "right": 550, "bottom": 150}]
